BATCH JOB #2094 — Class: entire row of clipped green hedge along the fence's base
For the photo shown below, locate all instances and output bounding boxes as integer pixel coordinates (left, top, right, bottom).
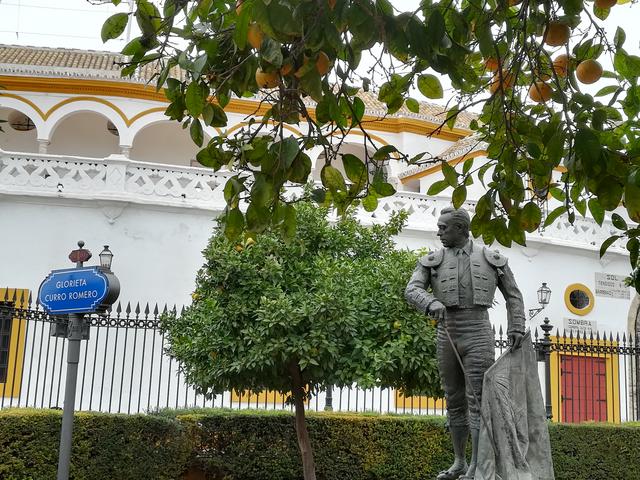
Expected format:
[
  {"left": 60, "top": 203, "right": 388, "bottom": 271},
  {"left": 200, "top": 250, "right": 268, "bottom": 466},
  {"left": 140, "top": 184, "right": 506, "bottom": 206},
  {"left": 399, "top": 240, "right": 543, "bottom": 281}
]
[{"left": 0, "top": 409, "right": 640, "bottom": 480}]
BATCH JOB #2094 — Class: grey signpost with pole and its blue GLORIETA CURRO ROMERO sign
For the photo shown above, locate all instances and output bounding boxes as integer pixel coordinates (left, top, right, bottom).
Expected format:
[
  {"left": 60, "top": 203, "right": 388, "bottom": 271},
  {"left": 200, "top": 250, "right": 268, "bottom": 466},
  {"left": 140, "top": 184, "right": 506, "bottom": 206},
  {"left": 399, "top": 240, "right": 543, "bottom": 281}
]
[{"left": 38, "top": 241, "right": 120, "bottom": 480}]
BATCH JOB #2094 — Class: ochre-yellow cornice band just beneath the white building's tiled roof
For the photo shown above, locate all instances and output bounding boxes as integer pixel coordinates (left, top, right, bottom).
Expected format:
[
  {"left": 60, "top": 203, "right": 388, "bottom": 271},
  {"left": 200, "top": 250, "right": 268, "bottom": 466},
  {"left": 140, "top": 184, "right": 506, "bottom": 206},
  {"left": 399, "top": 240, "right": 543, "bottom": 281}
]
[{"left": 0, "top": 75, "right": 471, "bottom": 141}]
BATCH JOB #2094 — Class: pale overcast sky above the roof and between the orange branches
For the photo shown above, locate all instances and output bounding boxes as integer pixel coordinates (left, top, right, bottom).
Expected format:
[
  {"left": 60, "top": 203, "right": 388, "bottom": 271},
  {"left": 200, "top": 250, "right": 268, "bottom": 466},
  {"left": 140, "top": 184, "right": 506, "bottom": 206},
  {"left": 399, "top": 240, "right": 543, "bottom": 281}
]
[{"left": 0, "top": 0, "right": 640, "bottom": 103}]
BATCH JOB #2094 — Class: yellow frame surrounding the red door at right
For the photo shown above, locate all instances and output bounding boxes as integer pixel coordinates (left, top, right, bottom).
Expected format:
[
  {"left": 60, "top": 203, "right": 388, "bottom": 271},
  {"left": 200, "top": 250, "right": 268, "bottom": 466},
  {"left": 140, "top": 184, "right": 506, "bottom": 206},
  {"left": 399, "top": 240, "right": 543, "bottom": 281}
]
[{"left": 550, "top": 337, "right": 620, "bottom": 423}]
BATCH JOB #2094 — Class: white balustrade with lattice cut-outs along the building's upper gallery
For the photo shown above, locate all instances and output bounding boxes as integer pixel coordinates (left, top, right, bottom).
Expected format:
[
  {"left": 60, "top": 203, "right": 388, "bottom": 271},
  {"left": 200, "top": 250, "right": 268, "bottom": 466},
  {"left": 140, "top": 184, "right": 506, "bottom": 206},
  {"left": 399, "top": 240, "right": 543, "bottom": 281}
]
[{"left": 0, "top": 150, "right": 624, "bottom": 253}]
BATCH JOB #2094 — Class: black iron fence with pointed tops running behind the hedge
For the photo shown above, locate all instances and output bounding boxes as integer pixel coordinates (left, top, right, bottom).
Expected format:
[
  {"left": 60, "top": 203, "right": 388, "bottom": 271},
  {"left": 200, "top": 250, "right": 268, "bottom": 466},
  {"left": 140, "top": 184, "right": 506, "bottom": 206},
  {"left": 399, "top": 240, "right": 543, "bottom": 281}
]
[{"left": 0, "top": 289, "right": 640, "bottom": 422}]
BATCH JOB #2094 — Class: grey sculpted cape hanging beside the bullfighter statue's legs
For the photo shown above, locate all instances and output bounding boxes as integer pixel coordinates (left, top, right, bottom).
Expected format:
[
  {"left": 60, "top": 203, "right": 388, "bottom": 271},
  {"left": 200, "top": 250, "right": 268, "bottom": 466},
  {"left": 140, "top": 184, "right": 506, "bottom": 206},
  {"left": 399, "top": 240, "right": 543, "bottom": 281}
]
[{"left": 475, "top": 332, "right": 555, "bottom": 480}]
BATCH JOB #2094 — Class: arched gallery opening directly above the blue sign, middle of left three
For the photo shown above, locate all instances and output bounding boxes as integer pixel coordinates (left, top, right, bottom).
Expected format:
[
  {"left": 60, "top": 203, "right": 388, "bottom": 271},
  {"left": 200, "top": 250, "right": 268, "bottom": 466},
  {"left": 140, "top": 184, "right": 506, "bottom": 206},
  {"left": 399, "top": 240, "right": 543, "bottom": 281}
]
[{"left": 48, "top": 111, "right": 120, "bottom": 158}]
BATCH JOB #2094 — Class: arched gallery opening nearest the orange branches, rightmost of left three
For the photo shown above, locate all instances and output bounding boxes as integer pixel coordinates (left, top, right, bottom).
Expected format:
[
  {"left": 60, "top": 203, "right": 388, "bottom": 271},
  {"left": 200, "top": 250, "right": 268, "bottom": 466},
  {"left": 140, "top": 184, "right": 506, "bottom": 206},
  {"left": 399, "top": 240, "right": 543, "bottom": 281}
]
[{"left": 129, "top": 121, "right": 209, "bottom": 166}]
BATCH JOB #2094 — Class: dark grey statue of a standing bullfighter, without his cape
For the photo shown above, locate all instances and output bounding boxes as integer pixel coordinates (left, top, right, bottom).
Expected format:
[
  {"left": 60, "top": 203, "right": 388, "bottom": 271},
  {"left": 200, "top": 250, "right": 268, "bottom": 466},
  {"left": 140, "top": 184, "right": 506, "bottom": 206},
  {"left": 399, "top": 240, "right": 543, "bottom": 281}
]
[{"left": 405, "top": 207, "right": 525, "bottom": 480}]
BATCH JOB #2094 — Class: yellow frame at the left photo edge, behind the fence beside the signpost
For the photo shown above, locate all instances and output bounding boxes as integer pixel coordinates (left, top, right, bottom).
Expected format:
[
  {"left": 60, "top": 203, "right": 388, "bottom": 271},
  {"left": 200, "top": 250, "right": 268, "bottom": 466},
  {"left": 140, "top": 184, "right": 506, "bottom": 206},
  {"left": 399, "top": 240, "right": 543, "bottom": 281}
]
[{"left": 0, "top": 288, "right": 30, "bottom": 398}]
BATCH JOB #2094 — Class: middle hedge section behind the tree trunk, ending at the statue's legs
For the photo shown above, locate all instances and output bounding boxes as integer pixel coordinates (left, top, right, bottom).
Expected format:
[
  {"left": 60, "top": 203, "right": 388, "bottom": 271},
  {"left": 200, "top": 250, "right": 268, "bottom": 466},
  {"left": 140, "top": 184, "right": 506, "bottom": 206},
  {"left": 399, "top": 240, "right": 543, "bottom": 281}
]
[{"left": 177, "top": 411, "right": 453, "bottom": 480}]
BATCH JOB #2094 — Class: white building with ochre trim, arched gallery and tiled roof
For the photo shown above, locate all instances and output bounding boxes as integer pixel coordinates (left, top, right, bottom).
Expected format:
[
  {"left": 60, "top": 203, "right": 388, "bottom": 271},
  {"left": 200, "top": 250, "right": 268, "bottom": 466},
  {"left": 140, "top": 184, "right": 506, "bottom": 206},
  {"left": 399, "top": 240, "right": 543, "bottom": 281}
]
[{"left": 0, "top": 46, "right": 638, "bottom": 419}]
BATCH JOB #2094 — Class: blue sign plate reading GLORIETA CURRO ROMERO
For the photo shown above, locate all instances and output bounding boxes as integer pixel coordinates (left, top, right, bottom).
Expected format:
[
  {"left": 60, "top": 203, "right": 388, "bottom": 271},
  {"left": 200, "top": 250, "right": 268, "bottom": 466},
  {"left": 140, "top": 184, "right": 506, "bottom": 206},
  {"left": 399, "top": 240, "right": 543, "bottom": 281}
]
[{"left": 38, "top": 267, "right": 109, "bottom": 315}]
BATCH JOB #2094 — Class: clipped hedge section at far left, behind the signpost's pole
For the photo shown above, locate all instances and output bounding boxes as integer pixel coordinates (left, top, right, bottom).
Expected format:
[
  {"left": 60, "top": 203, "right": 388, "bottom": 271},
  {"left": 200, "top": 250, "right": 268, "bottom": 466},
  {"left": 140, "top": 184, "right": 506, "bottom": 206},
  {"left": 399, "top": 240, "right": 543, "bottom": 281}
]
[{"left": 0, "top": 409, "right": 193, "bottom": 480}]
